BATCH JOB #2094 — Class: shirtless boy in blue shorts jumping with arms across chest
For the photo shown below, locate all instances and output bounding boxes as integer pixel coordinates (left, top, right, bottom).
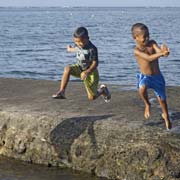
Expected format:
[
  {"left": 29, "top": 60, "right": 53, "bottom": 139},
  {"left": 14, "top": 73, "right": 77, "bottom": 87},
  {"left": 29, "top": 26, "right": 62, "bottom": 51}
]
[{"left": 131, "top": 23, "right": 172, "bottom": 130}]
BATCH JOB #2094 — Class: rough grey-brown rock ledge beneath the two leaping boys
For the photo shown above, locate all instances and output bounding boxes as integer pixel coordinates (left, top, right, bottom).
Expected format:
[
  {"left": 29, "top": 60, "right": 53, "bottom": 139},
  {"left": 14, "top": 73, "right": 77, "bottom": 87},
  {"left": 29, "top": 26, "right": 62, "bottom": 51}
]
[{"left": 0, "top": 78, "right": 180, "bottom": 180}]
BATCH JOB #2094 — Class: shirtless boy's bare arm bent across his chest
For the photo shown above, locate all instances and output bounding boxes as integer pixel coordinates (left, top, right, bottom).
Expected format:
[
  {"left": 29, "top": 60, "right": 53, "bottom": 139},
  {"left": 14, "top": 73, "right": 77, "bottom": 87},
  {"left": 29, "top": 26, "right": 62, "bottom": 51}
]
[{"left": 134, "top": 49, "right": 166, "bottom": 61}]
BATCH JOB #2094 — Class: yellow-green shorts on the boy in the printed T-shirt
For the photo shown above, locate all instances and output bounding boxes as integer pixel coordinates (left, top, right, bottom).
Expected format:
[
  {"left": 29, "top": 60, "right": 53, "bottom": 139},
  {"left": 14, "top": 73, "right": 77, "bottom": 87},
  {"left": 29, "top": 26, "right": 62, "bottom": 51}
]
[{"left": 70, "top": 64, "right": 99, "bottom": 97}]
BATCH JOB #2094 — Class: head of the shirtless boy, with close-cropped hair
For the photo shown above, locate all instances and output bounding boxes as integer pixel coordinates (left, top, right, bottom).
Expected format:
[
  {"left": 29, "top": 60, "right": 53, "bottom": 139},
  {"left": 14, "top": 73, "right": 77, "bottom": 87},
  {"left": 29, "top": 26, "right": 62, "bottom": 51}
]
[{"left": 131, "top": 23, "right": 149, "bottom": 44}]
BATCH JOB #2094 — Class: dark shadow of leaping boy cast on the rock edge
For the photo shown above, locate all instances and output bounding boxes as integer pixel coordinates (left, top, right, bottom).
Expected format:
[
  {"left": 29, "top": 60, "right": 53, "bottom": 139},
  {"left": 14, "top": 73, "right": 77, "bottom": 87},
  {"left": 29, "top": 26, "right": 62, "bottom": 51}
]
[{"left": 50, "top": 114, "right": 113, "bottom": 162}]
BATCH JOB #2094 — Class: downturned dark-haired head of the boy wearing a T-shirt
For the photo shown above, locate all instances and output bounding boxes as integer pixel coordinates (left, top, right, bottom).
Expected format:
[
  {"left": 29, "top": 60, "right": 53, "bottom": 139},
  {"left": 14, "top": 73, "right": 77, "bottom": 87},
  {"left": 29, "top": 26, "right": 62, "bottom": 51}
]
[{"left": 74, "top": 27, "right": 89, "bottom": 48}]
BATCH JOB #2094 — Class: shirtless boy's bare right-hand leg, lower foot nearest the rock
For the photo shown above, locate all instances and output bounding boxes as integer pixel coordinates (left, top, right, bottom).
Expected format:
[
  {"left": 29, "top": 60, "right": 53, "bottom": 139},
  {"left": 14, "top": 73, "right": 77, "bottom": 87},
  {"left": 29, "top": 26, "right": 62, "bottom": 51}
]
[{"left": 158, "top": 97, "right": 172, "bottom": 129}]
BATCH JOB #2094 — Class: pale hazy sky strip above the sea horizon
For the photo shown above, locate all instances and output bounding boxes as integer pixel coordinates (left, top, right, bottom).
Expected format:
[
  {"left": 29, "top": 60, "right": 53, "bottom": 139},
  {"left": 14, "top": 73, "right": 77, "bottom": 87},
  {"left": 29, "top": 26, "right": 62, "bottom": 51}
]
[{"left": 0, "top": 0, "right": 180, "bottom": 7}]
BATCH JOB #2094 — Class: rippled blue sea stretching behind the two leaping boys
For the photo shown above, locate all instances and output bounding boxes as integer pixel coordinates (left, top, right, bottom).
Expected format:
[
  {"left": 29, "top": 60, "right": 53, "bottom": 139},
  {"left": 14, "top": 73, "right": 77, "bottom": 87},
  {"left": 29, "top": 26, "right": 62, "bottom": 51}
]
[{"left": 0, "top": 8, "right": 180, "bottom": 85}]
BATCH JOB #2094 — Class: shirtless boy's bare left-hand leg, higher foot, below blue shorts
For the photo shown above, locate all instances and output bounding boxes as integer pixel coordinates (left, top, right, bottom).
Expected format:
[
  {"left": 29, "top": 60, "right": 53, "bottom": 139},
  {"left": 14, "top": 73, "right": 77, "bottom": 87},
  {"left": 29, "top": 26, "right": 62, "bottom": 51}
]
[{"left": 139, "top": 85, "right": 151, "bottom": 119}]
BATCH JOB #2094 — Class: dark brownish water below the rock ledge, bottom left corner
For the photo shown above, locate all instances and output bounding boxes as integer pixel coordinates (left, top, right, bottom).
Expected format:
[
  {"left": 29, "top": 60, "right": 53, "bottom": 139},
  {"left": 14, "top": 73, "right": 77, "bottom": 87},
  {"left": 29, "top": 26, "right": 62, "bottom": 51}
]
[{"left": 0, "top": 157, "right": 106, "bottom": 180}]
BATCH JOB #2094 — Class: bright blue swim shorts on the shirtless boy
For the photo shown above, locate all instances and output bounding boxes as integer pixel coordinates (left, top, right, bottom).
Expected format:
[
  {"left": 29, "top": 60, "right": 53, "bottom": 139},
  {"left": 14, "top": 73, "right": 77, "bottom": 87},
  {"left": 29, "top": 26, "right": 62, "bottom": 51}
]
[{"left": 136, "top": 73, "right": 166, "bottom": 100}]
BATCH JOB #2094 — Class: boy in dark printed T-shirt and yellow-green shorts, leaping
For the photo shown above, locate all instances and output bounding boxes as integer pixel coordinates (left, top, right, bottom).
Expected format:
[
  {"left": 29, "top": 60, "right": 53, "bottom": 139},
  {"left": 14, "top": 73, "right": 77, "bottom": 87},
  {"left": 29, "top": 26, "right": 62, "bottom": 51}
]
[{"left": 52, "top": 27, "right": 111, "bottom": 102}]
